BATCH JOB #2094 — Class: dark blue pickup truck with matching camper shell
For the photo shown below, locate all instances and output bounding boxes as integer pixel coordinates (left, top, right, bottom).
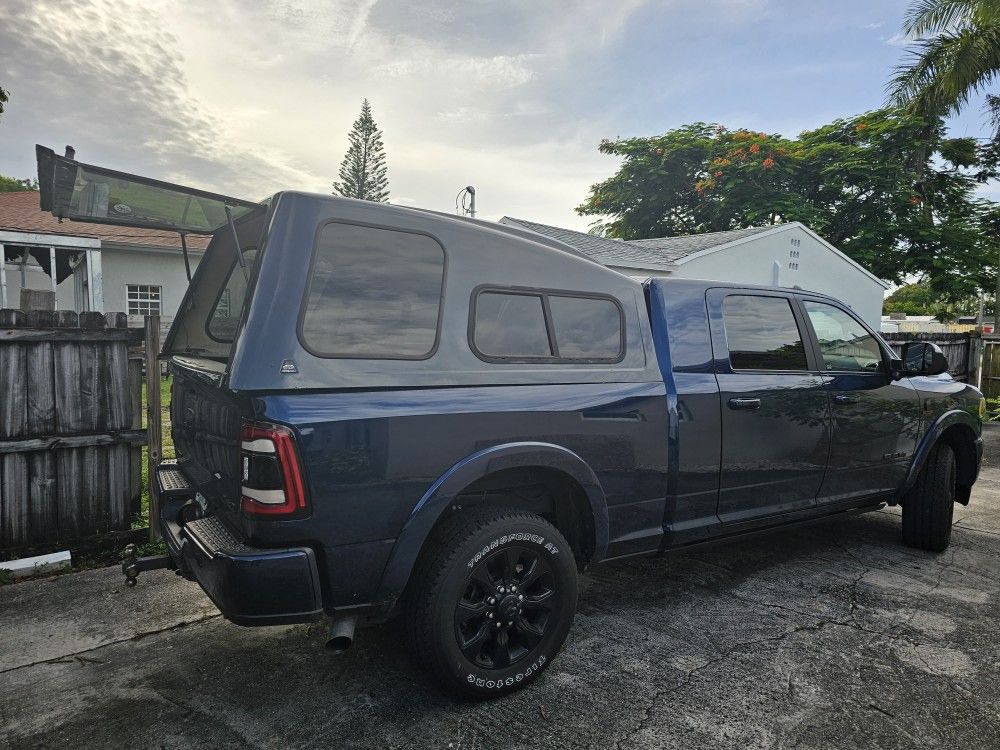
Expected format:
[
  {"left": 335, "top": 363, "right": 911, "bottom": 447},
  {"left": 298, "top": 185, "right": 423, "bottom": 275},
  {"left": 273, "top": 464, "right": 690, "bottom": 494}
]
[{"left": 37, "top": 150, "right": 984, "bottom": 697}]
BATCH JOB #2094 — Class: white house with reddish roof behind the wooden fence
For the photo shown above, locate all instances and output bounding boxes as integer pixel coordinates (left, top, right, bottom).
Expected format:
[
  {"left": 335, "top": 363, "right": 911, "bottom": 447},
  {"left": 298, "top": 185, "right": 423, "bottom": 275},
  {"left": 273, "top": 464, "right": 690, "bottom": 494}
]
[{"left": 0, "top": 192, "right": 209, "bottom": 322}]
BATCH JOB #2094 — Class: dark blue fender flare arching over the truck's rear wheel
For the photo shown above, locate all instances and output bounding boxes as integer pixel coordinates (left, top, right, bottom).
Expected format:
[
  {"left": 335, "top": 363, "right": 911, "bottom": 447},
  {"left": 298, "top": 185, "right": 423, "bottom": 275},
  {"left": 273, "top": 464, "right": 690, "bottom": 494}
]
[{"left": 378, "top": 442, "right": 608, "bottom": 601}]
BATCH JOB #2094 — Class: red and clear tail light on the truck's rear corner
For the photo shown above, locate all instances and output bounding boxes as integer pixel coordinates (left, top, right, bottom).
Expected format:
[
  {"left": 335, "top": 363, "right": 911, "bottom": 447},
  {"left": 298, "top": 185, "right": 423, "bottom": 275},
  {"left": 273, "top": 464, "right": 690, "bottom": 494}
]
[{"left": 240, "top": 422, "right": 307, "bottom": 516}]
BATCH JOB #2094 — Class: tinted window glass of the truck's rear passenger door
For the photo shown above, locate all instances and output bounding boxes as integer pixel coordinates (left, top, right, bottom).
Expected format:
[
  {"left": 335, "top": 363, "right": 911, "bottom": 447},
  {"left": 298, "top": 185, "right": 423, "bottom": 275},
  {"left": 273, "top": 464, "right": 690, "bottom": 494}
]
[{"left": 724, "top": 295, "right": 807, "bottom": 370}]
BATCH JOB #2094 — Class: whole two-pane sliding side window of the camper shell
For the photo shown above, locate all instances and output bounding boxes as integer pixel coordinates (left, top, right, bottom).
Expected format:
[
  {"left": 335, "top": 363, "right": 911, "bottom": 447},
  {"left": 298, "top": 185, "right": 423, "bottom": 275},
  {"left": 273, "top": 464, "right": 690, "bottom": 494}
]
[{"left": 470, "top": 289, "right": 624, "bottom": 363}]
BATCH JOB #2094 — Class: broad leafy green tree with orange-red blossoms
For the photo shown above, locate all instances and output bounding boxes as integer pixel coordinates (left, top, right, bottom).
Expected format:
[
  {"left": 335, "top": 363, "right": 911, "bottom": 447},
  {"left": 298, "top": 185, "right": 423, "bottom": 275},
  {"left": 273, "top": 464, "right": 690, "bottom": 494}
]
[{"left": 577, "top": 109, "right": 1000, "bottom": 299}]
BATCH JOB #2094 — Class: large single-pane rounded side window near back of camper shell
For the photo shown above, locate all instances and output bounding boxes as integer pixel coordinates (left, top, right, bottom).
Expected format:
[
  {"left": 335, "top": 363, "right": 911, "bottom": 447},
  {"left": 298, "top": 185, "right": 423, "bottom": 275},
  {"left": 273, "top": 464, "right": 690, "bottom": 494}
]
[{"left": 301, "top": 223, "right": 444, "bottom": 359}]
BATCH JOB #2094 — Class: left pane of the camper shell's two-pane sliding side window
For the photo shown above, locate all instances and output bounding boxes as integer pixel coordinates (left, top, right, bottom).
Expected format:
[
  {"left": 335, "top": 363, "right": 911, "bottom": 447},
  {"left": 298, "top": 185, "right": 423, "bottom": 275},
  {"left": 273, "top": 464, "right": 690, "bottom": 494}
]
[{"left": 473, "top": 292, "right": 552, "bottom": 357}]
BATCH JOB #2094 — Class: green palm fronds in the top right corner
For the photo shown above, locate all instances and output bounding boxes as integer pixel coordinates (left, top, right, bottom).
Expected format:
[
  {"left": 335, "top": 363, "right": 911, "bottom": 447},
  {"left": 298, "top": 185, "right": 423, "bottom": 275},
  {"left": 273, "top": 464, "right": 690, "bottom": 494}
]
[{"left": 889, "top": 0, "right": 1000, "bottom": 118}]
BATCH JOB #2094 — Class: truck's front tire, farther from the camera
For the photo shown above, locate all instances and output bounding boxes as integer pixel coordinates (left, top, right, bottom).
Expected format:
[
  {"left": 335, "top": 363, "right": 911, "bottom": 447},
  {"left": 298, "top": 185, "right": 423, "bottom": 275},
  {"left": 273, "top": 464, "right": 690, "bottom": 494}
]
[{"left": 903, "top": 443, "right": 956, "bottom": 552}]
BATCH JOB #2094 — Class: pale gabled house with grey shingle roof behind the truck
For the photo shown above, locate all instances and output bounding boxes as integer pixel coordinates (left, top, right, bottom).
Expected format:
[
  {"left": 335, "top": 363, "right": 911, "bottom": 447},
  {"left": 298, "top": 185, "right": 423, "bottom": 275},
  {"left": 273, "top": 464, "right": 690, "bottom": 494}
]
[{"left": 500, "top": 216, "right": 889, "bottom": 330}]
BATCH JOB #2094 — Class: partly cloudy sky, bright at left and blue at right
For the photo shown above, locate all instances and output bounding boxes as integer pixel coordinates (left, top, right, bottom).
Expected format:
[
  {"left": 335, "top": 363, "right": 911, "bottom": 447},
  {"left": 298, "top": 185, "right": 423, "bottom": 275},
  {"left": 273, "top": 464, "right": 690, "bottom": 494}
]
[{"left": 0, "top": 0, "right": 988, "bottom": 230}]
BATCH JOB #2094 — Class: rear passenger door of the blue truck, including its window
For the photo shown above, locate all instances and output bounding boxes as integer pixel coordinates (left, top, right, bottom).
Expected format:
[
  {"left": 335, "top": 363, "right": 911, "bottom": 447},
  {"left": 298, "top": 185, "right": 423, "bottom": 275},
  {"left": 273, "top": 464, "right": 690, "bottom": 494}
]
[{"left": 708, "top": 289, "right": 830, "bottom": 523}]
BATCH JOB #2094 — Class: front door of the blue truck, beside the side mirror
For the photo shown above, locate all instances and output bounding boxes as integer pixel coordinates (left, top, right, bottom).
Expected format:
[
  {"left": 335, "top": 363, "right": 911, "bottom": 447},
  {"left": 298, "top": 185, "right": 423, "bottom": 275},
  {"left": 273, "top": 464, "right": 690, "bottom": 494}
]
[{"left": 800, "top": 296, "right": 920, "bottom": 503}]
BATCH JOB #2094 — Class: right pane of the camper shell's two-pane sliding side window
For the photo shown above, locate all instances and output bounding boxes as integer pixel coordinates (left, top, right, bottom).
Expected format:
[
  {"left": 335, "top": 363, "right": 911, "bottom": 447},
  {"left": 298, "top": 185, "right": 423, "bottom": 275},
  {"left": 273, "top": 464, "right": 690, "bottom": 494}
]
[{"left": 549, "top": 295, "right": 622, "bottom": 360}]
